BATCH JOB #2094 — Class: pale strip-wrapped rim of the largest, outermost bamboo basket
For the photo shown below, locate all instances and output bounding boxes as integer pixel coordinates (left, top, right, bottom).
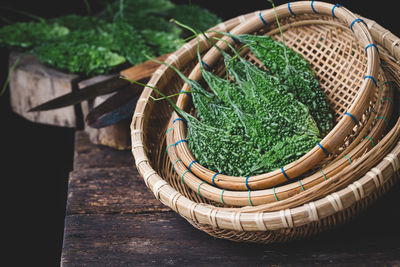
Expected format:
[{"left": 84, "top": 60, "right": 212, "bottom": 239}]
[{"left": 131, "top": 5, "right": 400, "bottom": 231}]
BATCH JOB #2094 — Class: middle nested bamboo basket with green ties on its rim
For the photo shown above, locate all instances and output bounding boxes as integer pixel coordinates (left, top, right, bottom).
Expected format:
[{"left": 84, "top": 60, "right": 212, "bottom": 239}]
[{"left": 166, "top": 74, "right": 393, "bottom": 206}]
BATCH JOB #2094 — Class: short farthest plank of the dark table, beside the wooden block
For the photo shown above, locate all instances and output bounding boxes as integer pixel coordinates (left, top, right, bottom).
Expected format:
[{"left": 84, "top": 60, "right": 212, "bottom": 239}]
[{"left": 74, "top": 131, "right": 134, "bottom": 170}]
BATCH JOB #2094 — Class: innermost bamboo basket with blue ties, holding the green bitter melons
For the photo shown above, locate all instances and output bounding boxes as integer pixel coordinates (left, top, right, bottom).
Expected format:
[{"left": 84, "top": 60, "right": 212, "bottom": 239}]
[{"left": 173, "top": 1, "right": 379, "bottom": 190}]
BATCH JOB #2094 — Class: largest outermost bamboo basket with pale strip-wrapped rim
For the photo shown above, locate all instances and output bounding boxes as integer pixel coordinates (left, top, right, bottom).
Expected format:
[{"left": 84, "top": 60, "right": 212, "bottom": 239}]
[{"left": 131, "top": 8, "right": 400, "bottom": 243}]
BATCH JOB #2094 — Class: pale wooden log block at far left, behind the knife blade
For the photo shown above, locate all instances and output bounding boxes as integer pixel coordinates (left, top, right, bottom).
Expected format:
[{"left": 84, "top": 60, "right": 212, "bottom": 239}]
[{"left": 9, "top": 52, "right": 79, "bottom": 128}]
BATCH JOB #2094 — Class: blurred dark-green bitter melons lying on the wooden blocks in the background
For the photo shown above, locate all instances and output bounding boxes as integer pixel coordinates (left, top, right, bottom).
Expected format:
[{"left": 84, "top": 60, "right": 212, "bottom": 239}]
[{"left": 0, "top": 0, "right": 220, "bottom": 76}]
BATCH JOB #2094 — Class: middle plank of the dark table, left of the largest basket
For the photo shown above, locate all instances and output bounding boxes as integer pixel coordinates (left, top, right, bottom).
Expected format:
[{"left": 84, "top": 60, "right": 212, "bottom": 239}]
[{"left": 66, "top": 167, "right": 170, "bottom": 215}]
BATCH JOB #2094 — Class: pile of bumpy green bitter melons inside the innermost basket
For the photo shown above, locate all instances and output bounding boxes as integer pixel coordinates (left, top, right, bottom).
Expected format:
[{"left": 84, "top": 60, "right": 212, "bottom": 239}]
[{"left": 152, "top": 21, "right": 332, "bottom": 176}]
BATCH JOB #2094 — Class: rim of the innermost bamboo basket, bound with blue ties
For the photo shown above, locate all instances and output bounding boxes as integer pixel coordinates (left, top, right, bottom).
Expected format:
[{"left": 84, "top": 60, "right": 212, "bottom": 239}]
[{"left": 173, "top": 1, "right": 379, "bottom": 190}]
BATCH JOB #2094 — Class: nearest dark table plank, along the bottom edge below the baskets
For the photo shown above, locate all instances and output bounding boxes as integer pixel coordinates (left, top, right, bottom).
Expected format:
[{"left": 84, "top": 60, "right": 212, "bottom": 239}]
[{"left": 61, "top": 212, "right": 400, "bottom": 266}]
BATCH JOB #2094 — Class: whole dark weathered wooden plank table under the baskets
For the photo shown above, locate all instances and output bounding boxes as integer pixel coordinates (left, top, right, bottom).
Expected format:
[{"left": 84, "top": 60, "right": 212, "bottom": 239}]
[{"left": 61, "top": 131, "right": 400, "bottom": 267}]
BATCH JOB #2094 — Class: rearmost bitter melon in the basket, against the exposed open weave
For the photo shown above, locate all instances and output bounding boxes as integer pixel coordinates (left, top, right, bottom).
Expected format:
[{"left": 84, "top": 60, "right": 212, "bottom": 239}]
[{"left": 234, "top": 34, "right": 332, "bottom": 135}]
